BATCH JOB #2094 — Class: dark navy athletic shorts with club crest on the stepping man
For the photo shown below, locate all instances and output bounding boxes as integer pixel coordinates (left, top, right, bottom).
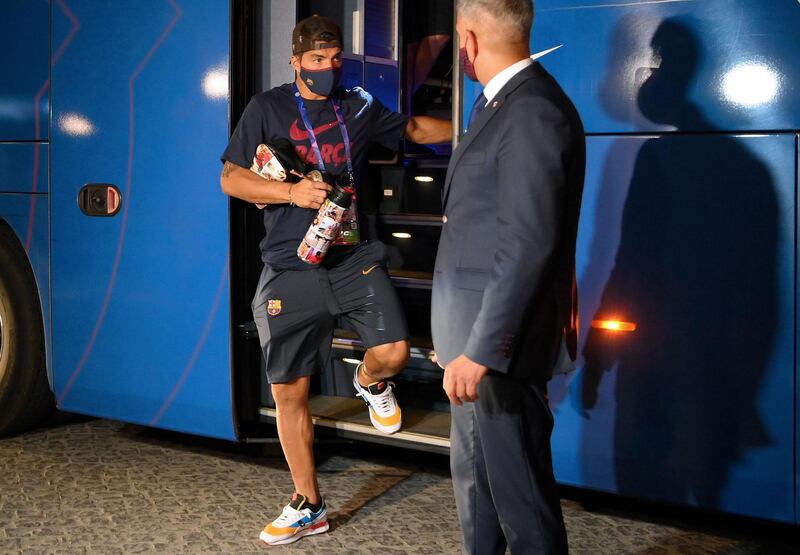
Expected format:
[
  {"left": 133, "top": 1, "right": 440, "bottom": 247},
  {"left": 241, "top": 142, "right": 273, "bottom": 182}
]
[{"left": 252, "top": 241, "right": 408, "bottom": 383}]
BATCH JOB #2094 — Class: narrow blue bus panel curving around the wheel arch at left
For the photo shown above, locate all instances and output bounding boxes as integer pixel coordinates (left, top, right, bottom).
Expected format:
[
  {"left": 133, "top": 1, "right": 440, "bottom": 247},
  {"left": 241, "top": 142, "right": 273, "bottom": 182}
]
[{"left": 0, "top": 193, "right": 53, "bottom": 385}]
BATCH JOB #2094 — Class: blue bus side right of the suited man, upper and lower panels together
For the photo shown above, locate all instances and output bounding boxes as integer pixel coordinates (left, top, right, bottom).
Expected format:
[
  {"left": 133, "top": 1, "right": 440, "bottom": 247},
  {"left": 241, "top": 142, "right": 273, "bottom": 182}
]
[{"left": 462, "top": 0, "right": 800, "bottom": 523}]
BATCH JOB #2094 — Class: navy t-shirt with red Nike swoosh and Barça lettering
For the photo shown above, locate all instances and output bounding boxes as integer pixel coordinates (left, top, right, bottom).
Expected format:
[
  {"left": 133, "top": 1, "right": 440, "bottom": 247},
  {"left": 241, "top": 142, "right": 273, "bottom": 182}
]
[{"left": 222, "top": 83, "right": 408, "bottom": 270}]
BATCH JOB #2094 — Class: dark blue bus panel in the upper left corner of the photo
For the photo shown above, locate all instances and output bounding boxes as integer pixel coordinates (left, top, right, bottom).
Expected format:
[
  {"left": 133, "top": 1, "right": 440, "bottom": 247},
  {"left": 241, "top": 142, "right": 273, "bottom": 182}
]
[{"left": 0, "top": 0, "right": 50, "bottom": 141}]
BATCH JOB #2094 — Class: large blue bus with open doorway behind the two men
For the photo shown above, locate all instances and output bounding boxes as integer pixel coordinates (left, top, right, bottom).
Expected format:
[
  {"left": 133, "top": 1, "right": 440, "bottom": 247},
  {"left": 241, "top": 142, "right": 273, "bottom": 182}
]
[{"left": 0, "top": 0, "right": 800, "bottom": 524}]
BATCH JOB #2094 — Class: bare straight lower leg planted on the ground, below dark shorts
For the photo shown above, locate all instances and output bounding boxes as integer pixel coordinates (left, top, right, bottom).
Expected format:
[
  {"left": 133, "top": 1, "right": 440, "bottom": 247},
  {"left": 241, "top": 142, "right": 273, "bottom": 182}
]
[{"left": 272, "top": 376, "right": 321, "bottom": 505}]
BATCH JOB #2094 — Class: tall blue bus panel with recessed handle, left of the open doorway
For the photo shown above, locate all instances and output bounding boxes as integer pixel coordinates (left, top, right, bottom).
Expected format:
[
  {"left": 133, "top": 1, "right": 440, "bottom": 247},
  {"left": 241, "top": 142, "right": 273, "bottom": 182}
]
[{"left": 51, "top": 0, "right": 235, "bottom": 444}]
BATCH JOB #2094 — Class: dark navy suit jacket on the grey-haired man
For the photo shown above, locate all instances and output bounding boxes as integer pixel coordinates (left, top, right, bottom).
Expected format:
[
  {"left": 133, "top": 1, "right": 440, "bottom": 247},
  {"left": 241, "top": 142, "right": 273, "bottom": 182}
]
[{"left": 431, "top": 62, "right": 586, "bottom": 377}]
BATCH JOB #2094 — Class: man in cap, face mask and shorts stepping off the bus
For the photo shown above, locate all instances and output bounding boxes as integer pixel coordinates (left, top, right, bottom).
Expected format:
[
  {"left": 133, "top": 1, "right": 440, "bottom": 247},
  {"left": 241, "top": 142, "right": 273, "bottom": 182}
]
[{"left": 221, "top": 16, "right": 452, "bottom": 545}]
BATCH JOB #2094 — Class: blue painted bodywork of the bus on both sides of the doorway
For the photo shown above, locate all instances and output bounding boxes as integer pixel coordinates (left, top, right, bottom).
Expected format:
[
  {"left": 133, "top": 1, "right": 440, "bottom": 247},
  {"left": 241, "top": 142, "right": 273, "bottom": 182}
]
[{"left": 0, "top": 0, "right": 800, "bottom": 523}]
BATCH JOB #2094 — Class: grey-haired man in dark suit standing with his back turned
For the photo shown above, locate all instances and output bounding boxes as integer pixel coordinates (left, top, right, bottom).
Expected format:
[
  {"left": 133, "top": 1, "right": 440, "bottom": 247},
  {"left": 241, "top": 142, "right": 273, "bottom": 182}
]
[{"left": 431, "top": 0, "right": 585, "bottom": 555}]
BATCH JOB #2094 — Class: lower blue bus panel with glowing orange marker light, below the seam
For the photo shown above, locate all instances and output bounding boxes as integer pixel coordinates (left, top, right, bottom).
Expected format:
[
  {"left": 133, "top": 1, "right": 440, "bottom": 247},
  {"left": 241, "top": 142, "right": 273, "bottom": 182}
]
[{"left": 550, "top": 135, "right": 796, "bottom": 522}]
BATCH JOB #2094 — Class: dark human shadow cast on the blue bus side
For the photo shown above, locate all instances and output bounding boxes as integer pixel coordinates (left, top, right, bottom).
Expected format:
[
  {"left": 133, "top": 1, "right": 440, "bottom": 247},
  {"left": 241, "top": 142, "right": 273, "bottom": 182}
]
[{"left": 581, "top": 18, "right": 779, "bottom": 508}]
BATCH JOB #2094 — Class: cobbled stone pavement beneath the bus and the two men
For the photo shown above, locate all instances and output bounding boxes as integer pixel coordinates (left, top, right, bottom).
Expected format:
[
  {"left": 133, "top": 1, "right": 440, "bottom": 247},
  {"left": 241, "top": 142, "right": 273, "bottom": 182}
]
[{"left": 0, "top": 420, "right": 800, "bottom": 555}]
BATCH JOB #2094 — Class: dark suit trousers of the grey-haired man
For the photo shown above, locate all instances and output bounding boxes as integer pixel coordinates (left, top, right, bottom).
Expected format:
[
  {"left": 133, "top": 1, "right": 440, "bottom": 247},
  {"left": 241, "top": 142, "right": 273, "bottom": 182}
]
[{"left": 450, "top": 371, "right": 567, "bottom": 555}]
